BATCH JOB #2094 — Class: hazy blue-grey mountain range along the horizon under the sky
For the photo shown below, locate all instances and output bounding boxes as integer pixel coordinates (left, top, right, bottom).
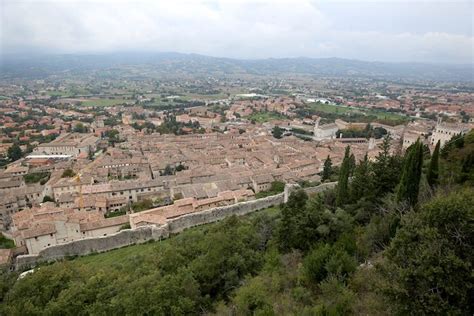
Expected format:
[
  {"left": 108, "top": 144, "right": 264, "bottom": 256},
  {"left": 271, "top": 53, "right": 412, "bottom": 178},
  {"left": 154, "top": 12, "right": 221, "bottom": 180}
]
[{"left": 0, "top": 53, "right": 474, "bottom": 82}]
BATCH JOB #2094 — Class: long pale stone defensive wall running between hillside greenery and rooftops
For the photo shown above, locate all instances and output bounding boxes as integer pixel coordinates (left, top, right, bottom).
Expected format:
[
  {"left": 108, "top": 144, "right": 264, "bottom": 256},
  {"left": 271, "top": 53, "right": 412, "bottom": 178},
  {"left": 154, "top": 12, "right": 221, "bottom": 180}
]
[{"left": 14, "top": 182, "right": 336, "bottom": 270}]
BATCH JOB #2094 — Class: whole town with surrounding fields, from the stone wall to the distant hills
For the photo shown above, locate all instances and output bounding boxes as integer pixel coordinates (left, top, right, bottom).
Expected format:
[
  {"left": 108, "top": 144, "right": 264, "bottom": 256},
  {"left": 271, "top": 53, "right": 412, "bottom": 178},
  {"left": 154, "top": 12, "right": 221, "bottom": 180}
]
[{"left": 0, "top": 71, "right": 474, "bottom": 263}]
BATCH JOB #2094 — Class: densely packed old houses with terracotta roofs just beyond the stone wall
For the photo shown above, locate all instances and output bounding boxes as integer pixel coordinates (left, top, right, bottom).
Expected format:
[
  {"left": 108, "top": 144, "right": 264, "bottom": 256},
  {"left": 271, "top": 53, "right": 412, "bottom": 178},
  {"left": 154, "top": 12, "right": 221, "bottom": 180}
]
[{"left": 0, "top": 100, "right": 472, "bottom": 260}]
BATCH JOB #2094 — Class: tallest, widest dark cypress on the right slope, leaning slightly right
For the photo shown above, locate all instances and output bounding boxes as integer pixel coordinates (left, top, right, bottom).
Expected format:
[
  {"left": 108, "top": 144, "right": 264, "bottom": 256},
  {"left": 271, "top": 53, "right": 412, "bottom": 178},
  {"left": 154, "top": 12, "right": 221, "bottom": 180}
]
[{"left": 397, "top": 140, "right": 423, "bottom": 206}]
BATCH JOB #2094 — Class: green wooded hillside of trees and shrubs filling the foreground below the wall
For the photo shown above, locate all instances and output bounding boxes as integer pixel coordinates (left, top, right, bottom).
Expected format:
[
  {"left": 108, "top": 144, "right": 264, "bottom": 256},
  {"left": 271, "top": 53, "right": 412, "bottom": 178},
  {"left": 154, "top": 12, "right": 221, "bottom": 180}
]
[{"left": 0, "top": 132, "right": 474, "bottom": 315}]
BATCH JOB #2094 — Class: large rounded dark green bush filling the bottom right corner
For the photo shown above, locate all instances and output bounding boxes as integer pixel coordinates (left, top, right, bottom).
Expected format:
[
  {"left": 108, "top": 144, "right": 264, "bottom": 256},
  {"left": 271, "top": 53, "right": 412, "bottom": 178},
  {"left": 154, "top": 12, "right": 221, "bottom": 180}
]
[{"left": 382, "top": 188, "right": 474, "bottom": 315}]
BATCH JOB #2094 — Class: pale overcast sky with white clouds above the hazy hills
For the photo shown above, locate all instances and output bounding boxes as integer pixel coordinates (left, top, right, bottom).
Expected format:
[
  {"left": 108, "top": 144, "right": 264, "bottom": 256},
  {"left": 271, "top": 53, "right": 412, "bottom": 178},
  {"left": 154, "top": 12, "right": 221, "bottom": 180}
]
[{"left": 0, "top": 0, "right": 474, "bottom": 63}]
